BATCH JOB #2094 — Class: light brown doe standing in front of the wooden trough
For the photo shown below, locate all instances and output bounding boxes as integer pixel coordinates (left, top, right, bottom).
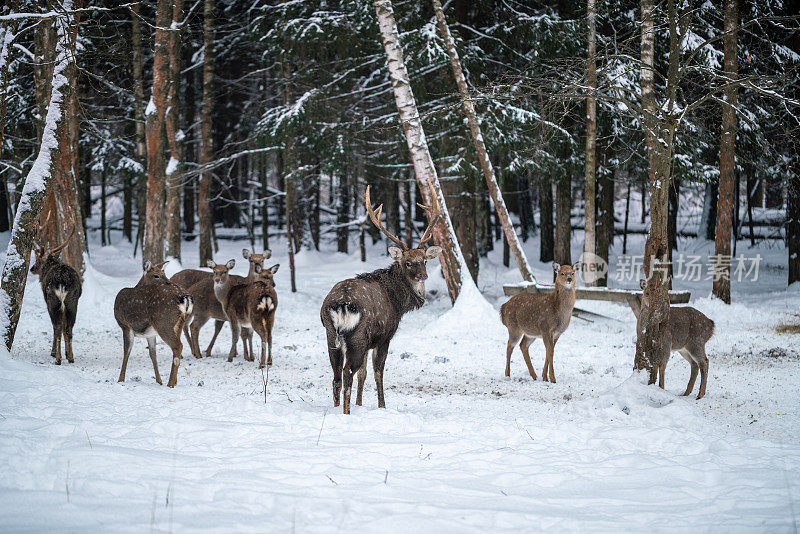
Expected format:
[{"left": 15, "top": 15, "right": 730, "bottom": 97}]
[{"left": 500, "top": 262, "right": 578, "bottom": 383}]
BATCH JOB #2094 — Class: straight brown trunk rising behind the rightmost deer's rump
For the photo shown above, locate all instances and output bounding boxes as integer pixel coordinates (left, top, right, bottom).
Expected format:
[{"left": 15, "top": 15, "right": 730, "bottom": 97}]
[{"left": 712, "top": 0, "right": 739, "bottom": 304}]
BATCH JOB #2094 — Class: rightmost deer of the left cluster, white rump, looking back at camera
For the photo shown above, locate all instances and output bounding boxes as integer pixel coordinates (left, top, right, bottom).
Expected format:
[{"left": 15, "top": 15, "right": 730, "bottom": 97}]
[{"left": 225, "top": 264, "right": 279, "bottom": 369}]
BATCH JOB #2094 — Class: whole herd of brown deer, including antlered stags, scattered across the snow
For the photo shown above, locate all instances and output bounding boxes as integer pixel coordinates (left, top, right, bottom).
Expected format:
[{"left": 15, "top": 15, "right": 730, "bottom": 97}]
[{"left": 31, "top": 187, "right": 714, "bottom": 414}]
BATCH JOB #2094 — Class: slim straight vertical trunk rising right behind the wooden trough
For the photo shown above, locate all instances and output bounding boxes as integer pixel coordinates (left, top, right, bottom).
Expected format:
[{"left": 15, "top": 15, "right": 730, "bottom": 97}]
[{"left": 581, "top": 0, "right": 597, "bottom": 286}]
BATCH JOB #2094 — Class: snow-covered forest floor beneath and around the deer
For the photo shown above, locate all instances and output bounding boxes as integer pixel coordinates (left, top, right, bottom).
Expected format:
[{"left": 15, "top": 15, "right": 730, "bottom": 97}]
[{"left": 0, "top": 234, "right": 800, "bottom": 532}]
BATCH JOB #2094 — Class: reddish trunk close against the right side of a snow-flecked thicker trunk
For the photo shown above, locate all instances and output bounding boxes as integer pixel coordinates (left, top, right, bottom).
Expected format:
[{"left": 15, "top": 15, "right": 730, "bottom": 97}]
[{"left": 166, "top": 0, "right": 183, "bottom": 261}]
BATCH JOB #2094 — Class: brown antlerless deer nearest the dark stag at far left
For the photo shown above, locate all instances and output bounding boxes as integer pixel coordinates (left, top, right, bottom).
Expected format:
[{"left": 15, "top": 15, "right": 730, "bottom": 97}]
[{"left": 114, "top": 261, "right": 194, "bottom": 387}]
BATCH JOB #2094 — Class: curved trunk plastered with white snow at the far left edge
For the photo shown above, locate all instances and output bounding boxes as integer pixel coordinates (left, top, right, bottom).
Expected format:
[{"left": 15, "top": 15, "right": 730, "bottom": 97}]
[{"left": 0, "top": 0, "right": 77, "bottom": 350}]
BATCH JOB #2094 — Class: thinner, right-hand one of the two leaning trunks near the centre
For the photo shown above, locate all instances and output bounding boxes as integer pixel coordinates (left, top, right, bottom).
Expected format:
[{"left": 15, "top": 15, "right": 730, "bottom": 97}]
[{"left": 433, "top": 0, "right": 536, "bottom": 282}]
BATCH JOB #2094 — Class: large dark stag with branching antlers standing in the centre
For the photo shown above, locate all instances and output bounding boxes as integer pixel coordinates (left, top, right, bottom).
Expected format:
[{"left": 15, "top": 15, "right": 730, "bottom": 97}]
[{"left": 320, "top": 187, "right": 442, "bottom": 414}]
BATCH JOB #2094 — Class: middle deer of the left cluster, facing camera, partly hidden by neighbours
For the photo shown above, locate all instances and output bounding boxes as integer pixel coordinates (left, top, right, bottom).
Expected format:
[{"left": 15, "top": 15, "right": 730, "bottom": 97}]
[{"left": 184, "top": 260, "right": 238, "bottom": 358}]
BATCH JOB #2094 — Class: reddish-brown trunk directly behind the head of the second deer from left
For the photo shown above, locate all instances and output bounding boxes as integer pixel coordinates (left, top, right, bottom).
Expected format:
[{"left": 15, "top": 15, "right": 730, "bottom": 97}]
[{"left": 142, "top": 0, "right": 172, "bottom": 263}]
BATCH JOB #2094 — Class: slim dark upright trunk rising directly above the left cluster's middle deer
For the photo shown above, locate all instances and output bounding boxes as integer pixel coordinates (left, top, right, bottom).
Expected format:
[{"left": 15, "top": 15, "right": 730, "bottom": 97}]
[{"left": 197, "top": 0, "right": 214, "bottom": 265}]
